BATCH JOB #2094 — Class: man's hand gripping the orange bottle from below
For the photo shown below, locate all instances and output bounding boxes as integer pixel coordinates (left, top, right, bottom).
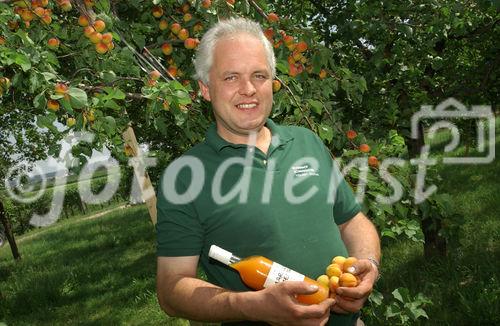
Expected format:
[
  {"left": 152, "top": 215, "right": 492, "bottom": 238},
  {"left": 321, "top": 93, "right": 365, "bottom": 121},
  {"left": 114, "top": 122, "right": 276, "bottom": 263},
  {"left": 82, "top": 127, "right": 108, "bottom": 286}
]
[{"left": 245, "top": 281, "right": 335, "bottom": 326}]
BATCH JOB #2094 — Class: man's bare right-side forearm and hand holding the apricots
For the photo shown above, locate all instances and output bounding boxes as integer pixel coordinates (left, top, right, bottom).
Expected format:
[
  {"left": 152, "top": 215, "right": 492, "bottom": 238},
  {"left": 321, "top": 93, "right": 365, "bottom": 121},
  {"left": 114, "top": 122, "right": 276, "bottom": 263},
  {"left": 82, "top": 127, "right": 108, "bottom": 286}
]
[{"left": 333, "top": 212, "right": 380, "bottom": 313}]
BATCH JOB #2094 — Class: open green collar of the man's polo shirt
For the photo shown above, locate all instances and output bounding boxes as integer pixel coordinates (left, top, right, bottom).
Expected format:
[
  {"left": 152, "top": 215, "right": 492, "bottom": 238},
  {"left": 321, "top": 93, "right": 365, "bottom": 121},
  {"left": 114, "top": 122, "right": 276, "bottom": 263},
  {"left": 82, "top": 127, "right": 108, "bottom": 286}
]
[{"left": 205, "top": 119, "right": 293, "bottom": 152}]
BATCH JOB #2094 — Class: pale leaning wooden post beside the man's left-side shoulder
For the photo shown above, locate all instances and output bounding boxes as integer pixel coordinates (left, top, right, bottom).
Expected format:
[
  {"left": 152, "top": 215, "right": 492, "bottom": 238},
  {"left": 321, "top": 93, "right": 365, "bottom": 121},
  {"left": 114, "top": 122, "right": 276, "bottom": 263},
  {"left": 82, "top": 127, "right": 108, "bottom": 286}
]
[{"left": 123, "top": 126, "right": 156, "bottom": 225}]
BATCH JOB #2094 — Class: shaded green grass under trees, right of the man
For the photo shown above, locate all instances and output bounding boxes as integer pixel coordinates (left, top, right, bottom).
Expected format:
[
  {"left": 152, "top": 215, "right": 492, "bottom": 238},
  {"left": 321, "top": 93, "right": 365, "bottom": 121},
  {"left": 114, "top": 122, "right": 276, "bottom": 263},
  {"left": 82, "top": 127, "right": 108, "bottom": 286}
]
[{"left": 372, "top": 119, "right": 500, "bottom": 325}]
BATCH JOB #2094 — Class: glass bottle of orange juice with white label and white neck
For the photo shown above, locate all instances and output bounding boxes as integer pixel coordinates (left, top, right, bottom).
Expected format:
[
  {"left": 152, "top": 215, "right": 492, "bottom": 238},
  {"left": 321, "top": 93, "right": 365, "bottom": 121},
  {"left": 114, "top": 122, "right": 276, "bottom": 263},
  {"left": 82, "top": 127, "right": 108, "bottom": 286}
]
[{"left": 208, "top": 245, "right": 329, "bottom": 304}]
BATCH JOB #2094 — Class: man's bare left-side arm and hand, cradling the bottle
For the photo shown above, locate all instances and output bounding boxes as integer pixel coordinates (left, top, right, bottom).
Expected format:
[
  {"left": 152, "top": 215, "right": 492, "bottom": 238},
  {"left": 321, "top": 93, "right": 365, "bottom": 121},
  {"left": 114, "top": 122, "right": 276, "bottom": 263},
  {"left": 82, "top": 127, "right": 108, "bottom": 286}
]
[{"left": 157, "top": 256, "right": 333, "bottom": 325}]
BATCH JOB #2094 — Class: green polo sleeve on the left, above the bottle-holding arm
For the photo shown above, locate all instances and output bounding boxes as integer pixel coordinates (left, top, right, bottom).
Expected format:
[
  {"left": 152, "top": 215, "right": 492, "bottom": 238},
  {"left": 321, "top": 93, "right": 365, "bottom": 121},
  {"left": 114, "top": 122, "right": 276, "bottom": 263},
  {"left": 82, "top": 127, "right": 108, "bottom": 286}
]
[{"left": 156, "top": 166, "right": 204, "bottom": 257}]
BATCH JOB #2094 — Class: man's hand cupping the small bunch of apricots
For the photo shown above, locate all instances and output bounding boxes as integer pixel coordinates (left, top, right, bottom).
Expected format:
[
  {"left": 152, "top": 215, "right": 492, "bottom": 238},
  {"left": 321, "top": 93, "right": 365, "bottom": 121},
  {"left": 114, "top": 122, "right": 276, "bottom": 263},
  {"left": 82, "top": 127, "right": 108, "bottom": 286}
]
[{"left": 332, "top": 259, "right": 379, "bottom": 314}]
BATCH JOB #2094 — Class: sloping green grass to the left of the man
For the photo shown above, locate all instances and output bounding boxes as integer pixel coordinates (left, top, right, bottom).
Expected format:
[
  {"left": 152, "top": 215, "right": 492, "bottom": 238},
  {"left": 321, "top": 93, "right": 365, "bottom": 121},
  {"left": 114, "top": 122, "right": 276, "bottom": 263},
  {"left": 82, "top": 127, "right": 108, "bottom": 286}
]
[{"left": 0, "top": 206, "right": 187, "bottom": 325}]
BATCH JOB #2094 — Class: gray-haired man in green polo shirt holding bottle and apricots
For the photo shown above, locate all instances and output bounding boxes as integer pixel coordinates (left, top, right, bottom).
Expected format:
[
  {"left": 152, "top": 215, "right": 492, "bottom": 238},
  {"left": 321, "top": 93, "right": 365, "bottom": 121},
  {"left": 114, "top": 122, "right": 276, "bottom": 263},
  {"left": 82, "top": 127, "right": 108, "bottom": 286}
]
[{"left": 157, "top": 19, "right": 380, "bottom": 325}]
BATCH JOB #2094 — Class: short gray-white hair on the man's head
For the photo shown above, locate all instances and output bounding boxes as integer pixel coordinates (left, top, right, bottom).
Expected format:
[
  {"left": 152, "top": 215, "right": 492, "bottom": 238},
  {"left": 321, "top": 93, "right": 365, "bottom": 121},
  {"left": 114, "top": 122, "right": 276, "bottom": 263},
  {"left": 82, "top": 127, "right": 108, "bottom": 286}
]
[{"left": 194, "top": 18, "right": 276, "bottom": 85}]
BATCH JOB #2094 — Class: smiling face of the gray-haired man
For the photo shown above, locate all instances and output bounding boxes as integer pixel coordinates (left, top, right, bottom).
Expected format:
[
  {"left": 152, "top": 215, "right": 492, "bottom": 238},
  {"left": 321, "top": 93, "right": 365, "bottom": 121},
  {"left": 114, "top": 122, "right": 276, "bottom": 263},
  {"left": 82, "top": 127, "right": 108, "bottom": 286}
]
[{"left": 199, "top": 34, "right": 273, "bottom": 144}]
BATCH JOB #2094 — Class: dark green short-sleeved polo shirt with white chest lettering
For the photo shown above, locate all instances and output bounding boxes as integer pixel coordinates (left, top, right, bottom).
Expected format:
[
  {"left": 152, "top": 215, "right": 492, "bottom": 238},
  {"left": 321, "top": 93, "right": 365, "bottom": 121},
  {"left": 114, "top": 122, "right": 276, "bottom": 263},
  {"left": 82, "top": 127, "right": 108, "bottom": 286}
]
[{"left": 157, "top": 120, "right": 360, "bottom": 325}]
